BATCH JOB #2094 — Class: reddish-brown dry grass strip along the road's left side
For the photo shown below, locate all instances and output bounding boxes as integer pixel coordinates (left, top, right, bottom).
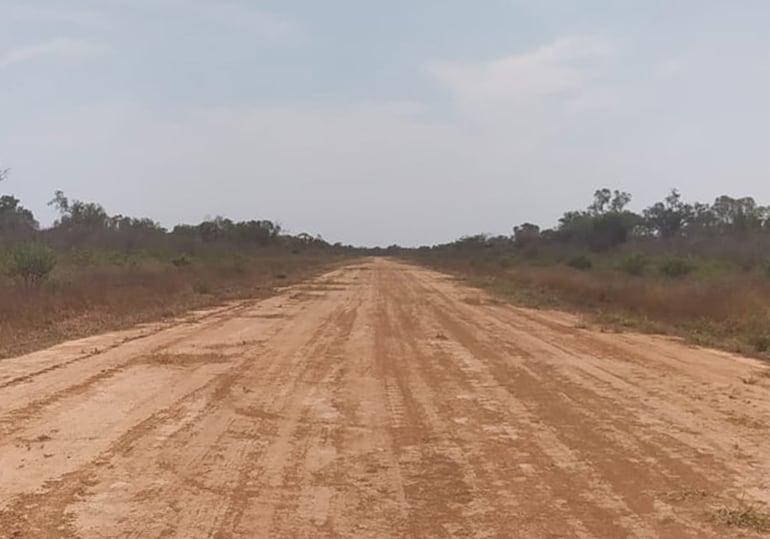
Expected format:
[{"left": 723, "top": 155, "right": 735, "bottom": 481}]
[{"left": 0, "top": 252, "right": 352, "bottom": 358}]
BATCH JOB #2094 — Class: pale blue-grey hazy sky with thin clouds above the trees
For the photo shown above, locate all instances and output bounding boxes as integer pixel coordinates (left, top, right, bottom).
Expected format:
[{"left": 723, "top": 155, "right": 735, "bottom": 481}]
[{"left": 0, "top": 0, "right": 770, "bottom": 245}]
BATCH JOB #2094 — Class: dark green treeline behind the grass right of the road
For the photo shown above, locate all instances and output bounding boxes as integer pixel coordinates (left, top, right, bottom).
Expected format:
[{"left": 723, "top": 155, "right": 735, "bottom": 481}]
[{"left": 432, "top": 188, "right": 770, "bottom": 267}]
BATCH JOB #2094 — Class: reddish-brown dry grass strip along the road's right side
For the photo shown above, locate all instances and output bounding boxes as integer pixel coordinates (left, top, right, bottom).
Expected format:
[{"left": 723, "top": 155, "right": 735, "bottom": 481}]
[{"left": 418, "top": 257, "right": 770, "bottom": 357}]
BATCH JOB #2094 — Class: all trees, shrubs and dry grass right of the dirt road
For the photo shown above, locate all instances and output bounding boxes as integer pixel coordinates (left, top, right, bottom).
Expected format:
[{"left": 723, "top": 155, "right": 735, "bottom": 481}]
[{"left": 402, "top": 189, "right": 770, "bottom": 356}]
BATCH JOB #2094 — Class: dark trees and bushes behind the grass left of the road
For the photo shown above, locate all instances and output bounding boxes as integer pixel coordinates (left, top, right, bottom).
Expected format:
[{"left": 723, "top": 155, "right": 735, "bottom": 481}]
[{"left": 0, "top": 170, "right": 358, "bottom": 289}]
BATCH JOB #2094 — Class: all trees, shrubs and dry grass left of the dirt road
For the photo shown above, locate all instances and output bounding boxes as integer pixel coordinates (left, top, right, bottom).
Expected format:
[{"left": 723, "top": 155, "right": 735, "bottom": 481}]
[{"left": 0, "top": 171, "right": 355, "bottom": 357}]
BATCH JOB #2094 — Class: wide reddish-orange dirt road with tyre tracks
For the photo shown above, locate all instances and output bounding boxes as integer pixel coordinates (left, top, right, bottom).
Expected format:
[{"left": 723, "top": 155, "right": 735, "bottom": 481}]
[{"left": 0, "top": 260, "right": 770, "bottom": 538}]
